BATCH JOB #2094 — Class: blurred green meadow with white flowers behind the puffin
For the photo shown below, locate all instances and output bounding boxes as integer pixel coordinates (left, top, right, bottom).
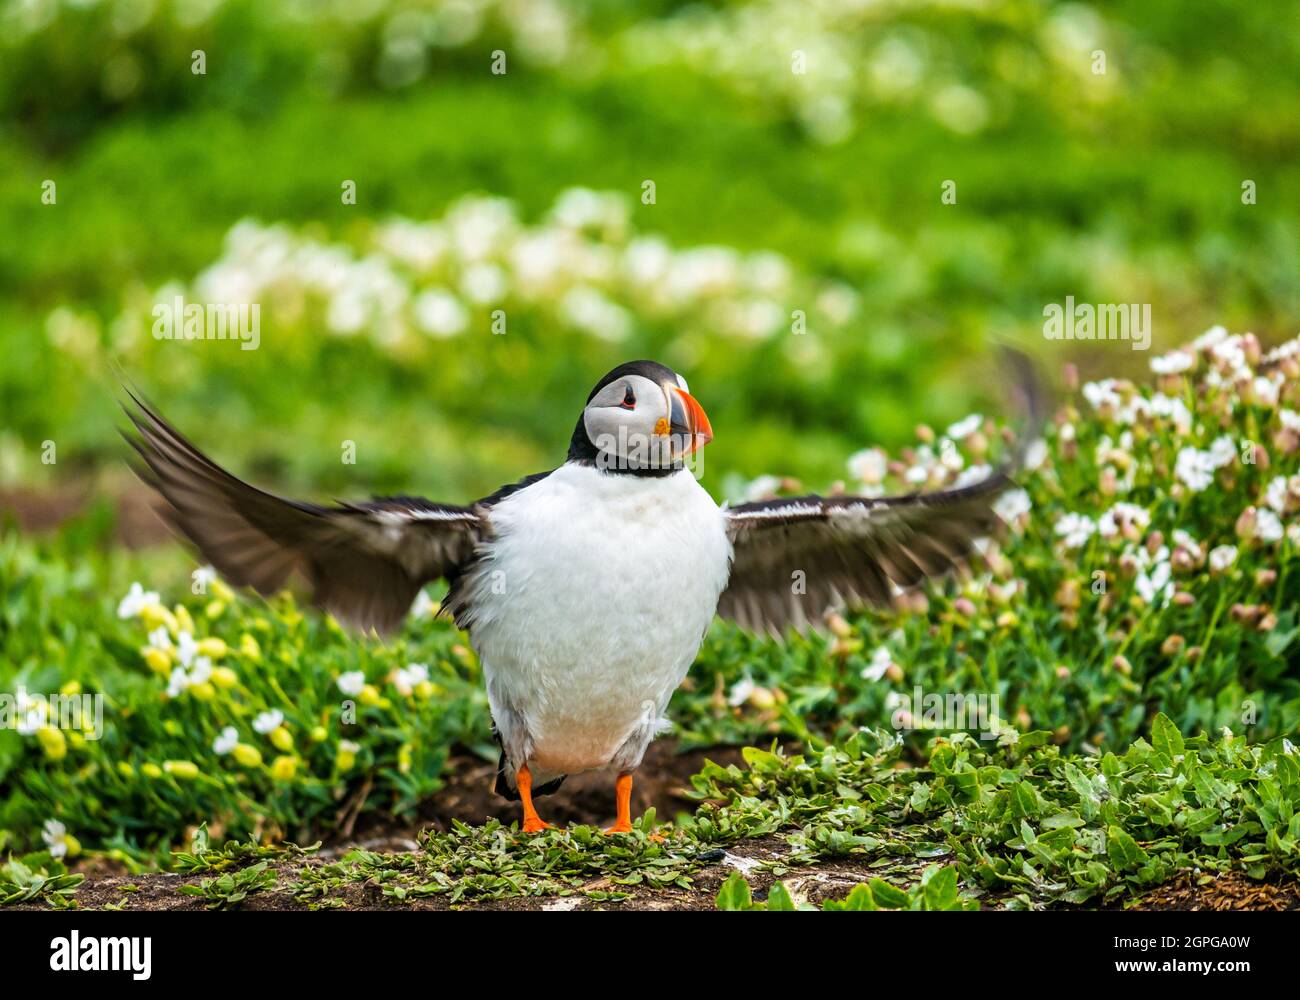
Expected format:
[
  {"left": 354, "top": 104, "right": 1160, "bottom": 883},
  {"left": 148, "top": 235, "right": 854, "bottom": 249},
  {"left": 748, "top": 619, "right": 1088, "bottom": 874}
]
[{"left": 0, "top": 0, "right": 1300, "bottom": 506}]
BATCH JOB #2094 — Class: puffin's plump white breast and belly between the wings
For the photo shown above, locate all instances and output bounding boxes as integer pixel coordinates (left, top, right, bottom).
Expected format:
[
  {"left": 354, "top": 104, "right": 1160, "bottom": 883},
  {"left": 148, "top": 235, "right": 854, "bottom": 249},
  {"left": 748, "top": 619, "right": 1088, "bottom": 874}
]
[{"left": 468, "top": 464, "right": 731, "bottom": 774}]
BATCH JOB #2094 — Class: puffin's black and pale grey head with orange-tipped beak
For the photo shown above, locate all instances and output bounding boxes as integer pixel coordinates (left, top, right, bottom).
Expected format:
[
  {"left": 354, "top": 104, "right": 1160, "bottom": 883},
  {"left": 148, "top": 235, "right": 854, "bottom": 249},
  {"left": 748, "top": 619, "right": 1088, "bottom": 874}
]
[{"left": 569, "top": 362, "right": 714, "bottom": 471}]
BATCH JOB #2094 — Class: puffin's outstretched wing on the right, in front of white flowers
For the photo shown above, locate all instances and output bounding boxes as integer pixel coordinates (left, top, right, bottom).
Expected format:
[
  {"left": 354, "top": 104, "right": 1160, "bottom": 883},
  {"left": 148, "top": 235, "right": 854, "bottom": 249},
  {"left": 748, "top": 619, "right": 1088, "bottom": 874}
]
[{"left": 718, "top": 472, "right": 1011, "bottom": 635}]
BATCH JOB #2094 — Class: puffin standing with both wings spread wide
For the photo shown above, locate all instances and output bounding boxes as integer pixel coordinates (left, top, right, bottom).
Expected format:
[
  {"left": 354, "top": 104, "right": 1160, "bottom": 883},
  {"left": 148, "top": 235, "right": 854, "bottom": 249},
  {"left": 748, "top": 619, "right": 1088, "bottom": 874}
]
[{"left": 124, "top": 360, "right": 1014, "bottom": 834}]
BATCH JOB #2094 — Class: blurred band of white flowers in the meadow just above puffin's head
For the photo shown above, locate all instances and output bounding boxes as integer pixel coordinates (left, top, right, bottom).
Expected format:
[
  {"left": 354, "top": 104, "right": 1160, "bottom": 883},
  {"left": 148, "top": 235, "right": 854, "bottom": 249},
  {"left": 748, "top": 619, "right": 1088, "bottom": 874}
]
[{"left": 122, "top": 189, "right": 858, "bottom": 350}]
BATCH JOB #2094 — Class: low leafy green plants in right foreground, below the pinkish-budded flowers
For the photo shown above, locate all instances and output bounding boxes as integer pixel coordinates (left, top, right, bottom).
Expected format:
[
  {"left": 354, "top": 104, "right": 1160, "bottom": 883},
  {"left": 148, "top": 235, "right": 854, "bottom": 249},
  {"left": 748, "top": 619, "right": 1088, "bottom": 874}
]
[{"left": 686, "top": 715, "right": 1300, "bottom": 909}]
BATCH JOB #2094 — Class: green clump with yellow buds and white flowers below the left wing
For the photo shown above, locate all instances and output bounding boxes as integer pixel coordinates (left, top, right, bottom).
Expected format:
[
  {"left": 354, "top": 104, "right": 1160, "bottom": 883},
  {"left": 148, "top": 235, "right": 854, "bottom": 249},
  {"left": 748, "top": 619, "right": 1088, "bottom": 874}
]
[{"left": 0, "top": 525, "right": 489, "bottom": 858}]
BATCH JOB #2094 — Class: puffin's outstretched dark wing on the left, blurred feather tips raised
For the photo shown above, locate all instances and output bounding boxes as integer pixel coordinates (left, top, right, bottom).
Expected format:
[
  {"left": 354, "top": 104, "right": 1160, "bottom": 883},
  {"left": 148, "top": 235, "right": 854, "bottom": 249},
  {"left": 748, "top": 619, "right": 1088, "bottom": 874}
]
[{"left": 126, "top": 393, "right": 489, "bottom": 635}]
